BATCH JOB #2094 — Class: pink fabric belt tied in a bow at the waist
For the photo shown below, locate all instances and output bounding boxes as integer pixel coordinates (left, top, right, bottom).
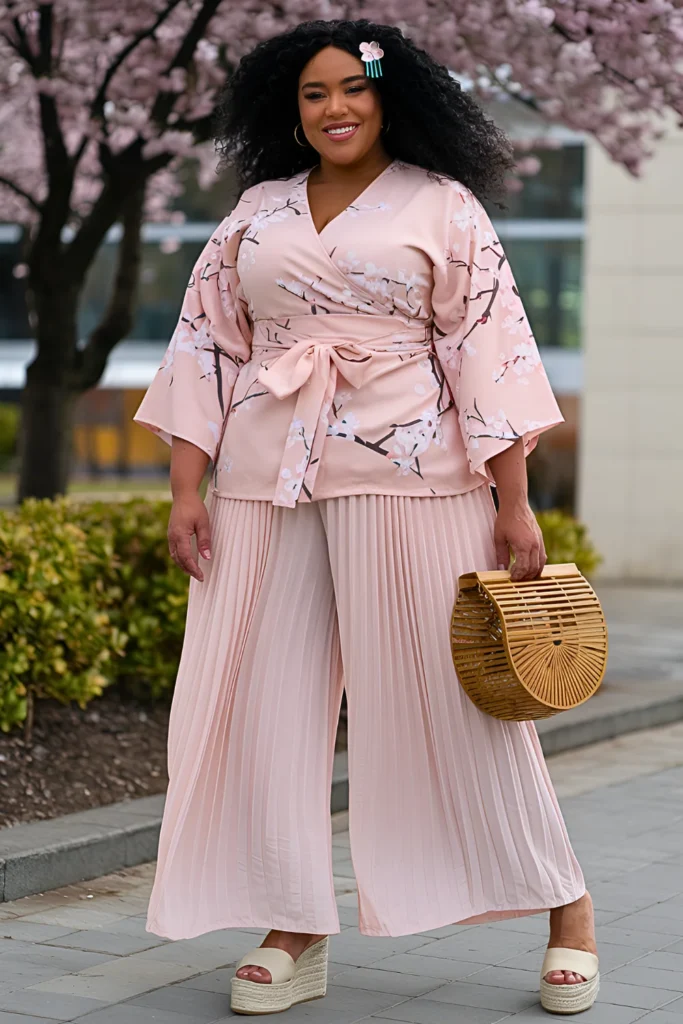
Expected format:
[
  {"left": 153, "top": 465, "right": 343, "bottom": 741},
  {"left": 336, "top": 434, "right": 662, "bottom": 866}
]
[{"left": 252, "top": 313, "right": 431, "bottom": 508}]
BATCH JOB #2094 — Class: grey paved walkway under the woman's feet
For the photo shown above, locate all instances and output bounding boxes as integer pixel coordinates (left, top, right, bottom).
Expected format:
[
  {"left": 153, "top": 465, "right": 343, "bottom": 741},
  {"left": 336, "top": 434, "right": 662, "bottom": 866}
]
[{"left": 0, "top": 724, "right": 683, "bottom": 1024}]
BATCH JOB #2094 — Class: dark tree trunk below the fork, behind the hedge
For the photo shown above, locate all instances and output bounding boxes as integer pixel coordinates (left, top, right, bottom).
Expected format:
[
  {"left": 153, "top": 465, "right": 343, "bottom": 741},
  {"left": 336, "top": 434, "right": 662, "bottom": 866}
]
[{"left": 17, "top": 360, "right": 78, "bottom": 501}]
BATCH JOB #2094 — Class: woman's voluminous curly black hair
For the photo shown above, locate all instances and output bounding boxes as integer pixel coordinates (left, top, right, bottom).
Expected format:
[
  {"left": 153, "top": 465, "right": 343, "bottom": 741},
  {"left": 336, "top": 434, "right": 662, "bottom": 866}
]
[{"left": 213, "top": 20, "right": 514, "bottom": 201}]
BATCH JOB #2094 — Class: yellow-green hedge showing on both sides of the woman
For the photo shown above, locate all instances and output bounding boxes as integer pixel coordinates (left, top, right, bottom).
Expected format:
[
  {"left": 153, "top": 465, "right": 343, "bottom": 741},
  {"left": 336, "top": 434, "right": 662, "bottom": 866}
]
[{"left": 0, "top": 499, "right": 598, "bottom": 732}]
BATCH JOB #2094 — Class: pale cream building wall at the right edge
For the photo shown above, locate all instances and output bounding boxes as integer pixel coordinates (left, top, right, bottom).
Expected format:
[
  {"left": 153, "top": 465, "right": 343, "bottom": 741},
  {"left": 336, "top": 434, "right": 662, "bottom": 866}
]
[{"left": 579, "top": 131, "right": 683, "bottom": 582}]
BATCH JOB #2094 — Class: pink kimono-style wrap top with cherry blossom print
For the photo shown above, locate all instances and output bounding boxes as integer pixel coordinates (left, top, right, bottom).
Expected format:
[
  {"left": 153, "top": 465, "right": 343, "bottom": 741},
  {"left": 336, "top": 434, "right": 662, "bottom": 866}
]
[{"left": 135, "top": 161, "right": 562, "bottom": 508}]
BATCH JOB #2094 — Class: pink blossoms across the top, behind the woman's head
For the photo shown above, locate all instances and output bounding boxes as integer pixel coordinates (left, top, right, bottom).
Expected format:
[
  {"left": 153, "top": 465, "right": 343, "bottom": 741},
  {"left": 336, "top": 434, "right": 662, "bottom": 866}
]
[{"left": 0, "top": 0, "right": 683, "bottom": 233}]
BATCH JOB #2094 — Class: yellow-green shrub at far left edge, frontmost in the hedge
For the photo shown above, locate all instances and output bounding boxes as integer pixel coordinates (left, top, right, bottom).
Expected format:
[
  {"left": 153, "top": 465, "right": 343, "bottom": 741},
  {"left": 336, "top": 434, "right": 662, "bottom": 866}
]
[{"left": 0, "top": 501, "right": 126, "bottom": 732}]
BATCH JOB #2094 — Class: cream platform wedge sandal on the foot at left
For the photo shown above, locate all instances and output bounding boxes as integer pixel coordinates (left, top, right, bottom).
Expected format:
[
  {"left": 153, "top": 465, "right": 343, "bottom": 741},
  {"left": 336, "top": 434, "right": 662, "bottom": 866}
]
[{"left": 230, "top": 935, "right": 328, "bottom": 1016}]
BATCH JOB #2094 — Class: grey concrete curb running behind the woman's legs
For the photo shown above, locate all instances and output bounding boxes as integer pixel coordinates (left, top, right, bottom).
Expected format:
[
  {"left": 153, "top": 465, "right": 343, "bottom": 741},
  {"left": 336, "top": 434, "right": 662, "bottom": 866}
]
[{"left": 0, "top": 686, "right": 683, "bottom": 905}]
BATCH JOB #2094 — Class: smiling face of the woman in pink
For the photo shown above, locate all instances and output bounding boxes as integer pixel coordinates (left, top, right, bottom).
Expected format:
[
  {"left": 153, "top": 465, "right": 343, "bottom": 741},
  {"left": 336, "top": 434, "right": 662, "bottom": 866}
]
[{"left": 299, "top": 46, "right": 383, "bottom": 165}]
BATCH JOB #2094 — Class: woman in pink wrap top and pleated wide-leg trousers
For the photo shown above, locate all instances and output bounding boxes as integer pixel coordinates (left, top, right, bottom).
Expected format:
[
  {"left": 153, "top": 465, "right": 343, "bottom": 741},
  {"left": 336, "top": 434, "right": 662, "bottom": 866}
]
[{"left": 136, "top": 22, "right": 598, "bottom": 1013}]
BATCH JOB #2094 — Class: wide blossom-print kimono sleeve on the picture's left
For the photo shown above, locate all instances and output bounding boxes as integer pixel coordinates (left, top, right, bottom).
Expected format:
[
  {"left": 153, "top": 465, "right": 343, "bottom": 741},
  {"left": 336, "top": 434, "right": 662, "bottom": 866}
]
[{"left": 133, "top": 186, "right": 258, "bottom": 461}]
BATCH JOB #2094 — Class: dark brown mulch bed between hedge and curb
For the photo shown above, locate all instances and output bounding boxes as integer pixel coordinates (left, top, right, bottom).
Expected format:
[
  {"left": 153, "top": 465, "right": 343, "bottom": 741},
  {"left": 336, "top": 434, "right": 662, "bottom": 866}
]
[{"left": 0, "top": 692, "right": 346, "bottom": 827}]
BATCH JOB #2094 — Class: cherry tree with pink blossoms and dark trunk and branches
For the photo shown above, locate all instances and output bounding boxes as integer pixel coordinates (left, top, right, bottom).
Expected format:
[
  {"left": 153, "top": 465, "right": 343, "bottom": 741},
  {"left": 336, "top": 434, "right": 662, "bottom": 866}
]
[{"left": 0, "top": 0, "right": 683, "bottom": 498}]
